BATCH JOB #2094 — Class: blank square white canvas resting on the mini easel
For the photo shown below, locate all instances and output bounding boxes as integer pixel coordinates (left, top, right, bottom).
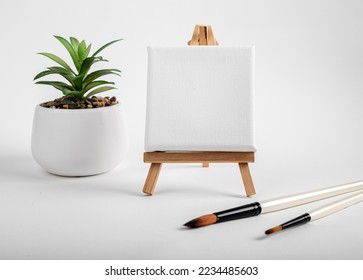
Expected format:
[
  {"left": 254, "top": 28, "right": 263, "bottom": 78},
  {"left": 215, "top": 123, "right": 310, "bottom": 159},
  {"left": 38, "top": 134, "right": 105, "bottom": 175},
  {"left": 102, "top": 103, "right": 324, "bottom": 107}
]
[{"left": 145, "top": 46, "right": 256, "bottom": 152}]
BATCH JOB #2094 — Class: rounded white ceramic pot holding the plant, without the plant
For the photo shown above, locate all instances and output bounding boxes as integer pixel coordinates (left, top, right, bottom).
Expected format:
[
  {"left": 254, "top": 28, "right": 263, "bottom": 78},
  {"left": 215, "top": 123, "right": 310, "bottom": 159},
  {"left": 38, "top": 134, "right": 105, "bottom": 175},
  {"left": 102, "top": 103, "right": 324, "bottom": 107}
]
[{"left": 31, "top": 103, "right": 128, "bottom": 176}]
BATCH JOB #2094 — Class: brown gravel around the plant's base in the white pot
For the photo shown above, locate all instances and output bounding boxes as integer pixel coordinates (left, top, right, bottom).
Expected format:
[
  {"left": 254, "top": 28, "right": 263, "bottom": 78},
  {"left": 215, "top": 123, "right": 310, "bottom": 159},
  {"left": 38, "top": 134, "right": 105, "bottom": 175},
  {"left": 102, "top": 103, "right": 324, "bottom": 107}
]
[{"left": 40, "top": 95, "right": 118, "bottom": 109}]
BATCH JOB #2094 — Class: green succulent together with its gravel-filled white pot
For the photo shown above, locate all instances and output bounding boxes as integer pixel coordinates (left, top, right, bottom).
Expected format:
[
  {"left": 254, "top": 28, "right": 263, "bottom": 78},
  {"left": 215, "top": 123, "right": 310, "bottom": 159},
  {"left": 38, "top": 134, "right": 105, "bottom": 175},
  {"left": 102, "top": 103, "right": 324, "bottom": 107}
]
[{"left": 31, "top": 36, "right": 127, "bottom": 176}]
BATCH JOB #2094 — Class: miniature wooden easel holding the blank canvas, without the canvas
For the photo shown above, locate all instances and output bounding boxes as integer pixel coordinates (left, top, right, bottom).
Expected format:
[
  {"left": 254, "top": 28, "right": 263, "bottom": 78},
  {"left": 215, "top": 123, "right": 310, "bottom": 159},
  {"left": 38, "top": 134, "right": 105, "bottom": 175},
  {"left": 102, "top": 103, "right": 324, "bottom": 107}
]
[{"left": 143, "top": 25, "right": 256, "bottom": 196}]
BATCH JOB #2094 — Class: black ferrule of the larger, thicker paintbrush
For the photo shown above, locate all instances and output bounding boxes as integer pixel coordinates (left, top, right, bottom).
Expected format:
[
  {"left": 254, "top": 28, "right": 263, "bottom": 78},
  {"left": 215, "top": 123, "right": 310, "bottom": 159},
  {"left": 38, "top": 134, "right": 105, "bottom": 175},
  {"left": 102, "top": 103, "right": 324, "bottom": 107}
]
[{"left": 214, "top": 202, "right": 262, "bottom": 223}]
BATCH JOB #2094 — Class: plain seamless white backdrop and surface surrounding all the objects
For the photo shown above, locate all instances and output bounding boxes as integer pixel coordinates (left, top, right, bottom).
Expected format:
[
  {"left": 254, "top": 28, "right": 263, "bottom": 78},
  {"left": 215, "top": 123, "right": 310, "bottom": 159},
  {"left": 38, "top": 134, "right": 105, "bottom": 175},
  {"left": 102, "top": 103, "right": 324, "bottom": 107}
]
[{"left": 0, "top": 0, "right": 363, "bottom": 259}]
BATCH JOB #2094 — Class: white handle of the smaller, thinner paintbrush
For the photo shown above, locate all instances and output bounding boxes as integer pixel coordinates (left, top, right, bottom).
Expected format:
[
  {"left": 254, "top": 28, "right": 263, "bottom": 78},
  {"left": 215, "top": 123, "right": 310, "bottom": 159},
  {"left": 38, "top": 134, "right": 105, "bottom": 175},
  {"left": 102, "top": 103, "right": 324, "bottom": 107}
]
[{"left": 309, "top": 192, "right": 363, "bottom": 221}]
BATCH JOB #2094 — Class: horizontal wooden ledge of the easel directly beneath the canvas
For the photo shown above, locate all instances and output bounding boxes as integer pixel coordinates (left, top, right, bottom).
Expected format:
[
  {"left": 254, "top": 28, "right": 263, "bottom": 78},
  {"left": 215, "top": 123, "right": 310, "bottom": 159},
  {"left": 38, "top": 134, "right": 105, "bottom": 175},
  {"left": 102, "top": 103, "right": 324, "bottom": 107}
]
[{"left": 144, "top": 152, "right": 255, "bottom": 163}]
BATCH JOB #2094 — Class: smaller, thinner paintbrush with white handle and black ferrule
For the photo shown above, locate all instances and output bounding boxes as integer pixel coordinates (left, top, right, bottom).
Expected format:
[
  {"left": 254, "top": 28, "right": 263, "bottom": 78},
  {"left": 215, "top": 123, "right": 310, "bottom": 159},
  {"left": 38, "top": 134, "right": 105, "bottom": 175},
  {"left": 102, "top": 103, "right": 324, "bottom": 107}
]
[{"left": 265, "top": 192, "right": 363, "bottom": 235}]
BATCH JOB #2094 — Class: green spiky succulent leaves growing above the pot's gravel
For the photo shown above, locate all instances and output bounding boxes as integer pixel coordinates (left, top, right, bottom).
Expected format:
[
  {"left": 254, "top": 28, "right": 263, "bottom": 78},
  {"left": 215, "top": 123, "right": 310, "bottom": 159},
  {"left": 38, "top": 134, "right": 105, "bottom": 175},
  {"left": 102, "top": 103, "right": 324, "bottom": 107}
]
[{"left": 34, "top": 36, "right": 122, "bottom": 100}]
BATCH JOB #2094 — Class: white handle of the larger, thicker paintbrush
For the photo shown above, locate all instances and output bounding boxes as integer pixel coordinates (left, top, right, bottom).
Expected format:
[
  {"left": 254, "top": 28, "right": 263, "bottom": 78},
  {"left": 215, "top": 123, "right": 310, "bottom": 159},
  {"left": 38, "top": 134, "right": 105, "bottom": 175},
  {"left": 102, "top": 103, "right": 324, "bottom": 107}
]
[{"left": 260, "top": 181, "right": 363, "bottom": 213}]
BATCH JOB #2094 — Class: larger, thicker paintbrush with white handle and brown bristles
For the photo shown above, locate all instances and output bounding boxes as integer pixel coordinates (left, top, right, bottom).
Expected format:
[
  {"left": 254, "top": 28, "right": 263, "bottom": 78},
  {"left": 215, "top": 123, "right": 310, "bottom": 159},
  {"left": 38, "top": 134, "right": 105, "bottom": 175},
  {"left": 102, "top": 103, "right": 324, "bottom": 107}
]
[{"left": 184, "top": 181, "right": 363, "bottom": 228}]
